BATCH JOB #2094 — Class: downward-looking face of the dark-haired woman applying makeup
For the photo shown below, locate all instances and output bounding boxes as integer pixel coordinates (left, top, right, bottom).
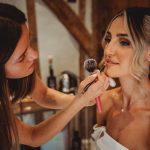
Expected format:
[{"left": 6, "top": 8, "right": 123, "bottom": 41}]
[{"left": 5, "top": 25, "right": 38, "bottom": 78}]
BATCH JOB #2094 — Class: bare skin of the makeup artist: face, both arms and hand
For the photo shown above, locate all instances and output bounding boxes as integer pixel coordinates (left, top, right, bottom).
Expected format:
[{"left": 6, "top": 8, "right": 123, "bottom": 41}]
[{"left": 5, "top": 24, "right": 108, "bottom": 147}]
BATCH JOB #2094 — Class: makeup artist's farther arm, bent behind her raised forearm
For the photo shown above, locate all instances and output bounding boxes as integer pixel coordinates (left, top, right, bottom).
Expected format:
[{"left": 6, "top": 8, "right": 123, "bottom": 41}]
[{"left": 30, "top": 75, "right": 75, "bottom": 109}]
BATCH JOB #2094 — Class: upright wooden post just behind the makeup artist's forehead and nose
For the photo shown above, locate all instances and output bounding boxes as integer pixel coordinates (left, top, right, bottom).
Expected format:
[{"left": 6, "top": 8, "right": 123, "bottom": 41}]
[{"left": 26, "top": 0, "right": 40, "bottom": 76}]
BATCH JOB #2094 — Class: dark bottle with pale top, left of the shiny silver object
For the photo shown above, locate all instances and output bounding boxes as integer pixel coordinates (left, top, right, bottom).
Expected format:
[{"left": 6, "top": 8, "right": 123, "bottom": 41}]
[{"left": 47, "top": 56, "right": 57, "bottom": 89}]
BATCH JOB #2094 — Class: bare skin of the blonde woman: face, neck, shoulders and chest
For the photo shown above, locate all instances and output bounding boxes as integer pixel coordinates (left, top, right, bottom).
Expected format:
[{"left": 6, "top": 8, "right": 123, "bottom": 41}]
[{"left": 98, "top": 17, "right": 150, "bottom": 150}]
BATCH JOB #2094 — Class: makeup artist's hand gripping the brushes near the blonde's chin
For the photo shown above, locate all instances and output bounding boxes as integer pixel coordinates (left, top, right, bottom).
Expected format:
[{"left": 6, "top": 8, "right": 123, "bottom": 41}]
[{"left": 75, "top": 71, "right": 109, "bottom": 107}]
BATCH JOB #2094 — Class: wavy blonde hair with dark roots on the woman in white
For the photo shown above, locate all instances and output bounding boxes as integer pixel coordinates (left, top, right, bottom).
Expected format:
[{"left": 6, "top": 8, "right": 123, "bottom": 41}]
[{"left": 101, "top": 7, "right": 150, "bottom": 83}]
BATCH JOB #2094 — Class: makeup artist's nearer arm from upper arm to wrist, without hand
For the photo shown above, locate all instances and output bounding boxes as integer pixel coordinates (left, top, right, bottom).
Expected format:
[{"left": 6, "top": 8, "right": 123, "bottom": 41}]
[{"left": 17, "top": 98, "right": 85, "bottom": 147}]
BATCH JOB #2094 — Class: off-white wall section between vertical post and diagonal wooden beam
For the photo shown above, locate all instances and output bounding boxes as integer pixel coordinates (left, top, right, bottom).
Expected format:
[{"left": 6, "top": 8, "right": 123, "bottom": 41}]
[{"left": 36, "top": 0, "right": 79, "bottom": 81}]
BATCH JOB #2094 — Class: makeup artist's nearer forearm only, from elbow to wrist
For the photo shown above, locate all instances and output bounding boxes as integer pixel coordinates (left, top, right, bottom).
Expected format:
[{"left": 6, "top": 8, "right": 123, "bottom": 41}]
[{"left": 28, "top": 96, "right": 83, "bottom": 146}]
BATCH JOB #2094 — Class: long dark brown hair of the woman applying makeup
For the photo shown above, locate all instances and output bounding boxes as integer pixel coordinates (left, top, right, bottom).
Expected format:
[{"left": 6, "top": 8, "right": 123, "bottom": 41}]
[{"left": 0, "top": 3, "right": 35, "bottom": 150}]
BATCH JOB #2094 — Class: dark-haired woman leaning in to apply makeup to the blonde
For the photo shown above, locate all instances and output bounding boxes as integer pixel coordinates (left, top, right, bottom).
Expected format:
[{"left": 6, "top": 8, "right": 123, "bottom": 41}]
[{"left": 0, "top": 3, "right": 105, "bottom": 150}]
